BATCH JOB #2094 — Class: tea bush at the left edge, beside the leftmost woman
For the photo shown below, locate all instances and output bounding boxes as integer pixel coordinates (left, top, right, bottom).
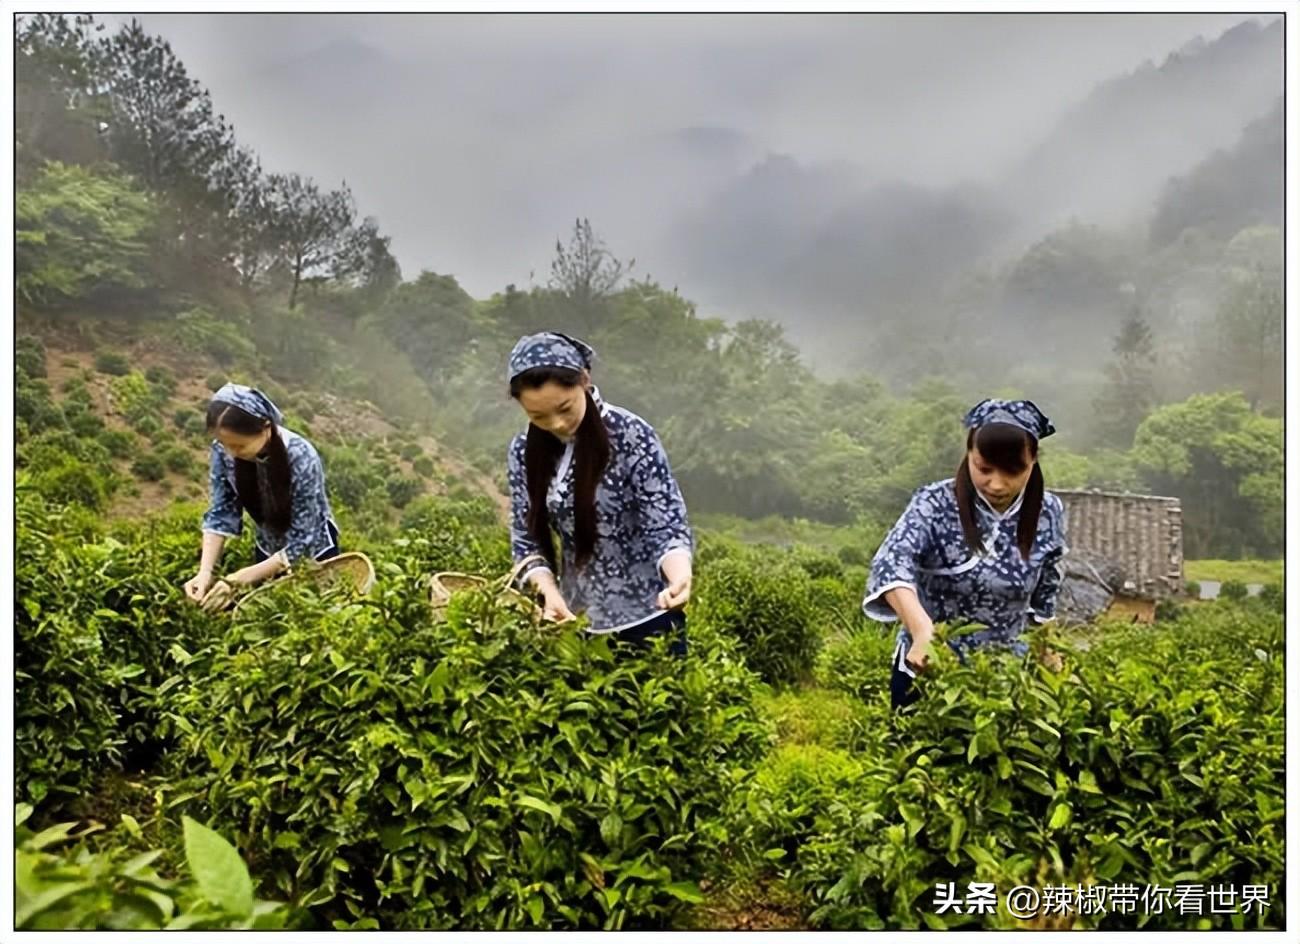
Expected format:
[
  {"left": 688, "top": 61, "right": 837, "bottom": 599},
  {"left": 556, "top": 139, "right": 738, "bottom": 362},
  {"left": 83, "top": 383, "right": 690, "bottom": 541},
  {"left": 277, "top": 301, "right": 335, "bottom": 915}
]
[{"left": 14, "top": 484, "right": 211, "bottom": 800}]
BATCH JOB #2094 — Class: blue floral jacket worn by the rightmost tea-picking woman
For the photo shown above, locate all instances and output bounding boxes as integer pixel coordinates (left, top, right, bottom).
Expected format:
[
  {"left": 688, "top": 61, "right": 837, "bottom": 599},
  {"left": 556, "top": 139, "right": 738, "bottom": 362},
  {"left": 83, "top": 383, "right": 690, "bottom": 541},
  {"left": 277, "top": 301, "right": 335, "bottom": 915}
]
[{"left": 862, "top": 479, "right": 1066, "bottom": 655}]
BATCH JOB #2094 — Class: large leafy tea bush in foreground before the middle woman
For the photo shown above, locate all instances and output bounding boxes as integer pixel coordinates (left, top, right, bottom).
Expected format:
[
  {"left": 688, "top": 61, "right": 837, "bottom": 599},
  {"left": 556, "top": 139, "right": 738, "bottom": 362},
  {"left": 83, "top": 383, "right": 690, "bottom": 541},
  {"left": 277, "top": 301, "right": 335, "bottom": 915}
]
[{"left": 172, "top": 569, "right": 767, "bottom": 930}]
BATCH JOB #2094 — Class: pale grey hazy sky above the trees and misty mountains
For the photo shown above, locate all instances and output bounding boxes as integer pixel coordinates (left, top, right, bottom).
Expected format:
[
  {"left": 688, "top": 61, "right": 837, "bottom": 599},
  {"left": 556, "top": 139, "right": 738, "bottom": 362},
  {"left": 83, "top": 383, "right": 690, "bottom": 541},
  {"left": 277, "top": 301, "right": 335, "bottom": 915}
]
[{"left": 101, "top": 13, "right": 1251, "bottom": 298}]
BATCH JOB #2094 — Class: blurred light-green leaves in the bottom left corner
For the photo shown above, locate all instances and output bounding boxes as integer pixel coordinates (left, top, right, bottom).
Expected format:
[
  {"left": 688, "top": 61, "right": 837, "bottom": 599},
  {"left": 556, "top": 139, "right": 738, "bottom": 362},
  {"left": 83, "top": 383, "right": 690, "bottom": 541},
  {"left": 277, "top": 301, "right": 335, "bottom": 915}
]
[{"left": 14, "top": 804, "right": 287, "bottom": 931}]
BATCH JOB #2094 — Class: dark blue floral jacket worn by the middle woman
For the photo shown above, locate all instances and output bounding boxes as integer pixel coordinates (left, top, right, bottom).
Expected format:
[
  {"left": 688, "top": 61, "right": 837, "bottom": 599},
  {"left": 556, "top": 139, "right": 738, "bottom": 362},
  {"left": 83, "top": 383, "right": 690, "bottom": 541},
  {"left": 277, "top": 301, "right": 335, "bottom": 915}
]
[{"left": 507, "top": 387, "right": 694, "bottom": 632}]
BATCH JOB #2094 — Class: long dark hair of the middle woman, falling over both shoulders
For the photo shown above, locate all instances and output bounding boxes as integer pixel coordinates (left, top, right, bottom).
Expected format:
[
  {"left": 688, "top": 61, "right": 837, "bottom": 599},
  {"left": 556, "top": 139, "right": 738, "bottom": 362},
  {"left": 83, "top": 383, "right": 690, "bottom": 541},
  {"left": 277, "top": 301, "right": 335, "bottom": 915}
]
[{"left": 510, "top": 367, "right": 610, "bottom": 570}]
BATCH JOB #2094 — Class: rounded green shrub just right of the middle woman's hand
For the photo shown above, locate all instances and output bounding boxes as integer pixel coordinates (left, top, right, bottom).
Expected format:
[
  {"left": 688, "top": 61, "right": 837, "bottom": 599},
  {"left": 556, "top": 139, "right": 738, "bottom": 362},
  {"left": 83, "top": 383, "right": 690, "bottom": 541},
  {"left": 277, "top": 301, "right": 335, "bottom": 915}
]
[{"left": 692, "top": 551, "right": 819, "bottom": 684}]
